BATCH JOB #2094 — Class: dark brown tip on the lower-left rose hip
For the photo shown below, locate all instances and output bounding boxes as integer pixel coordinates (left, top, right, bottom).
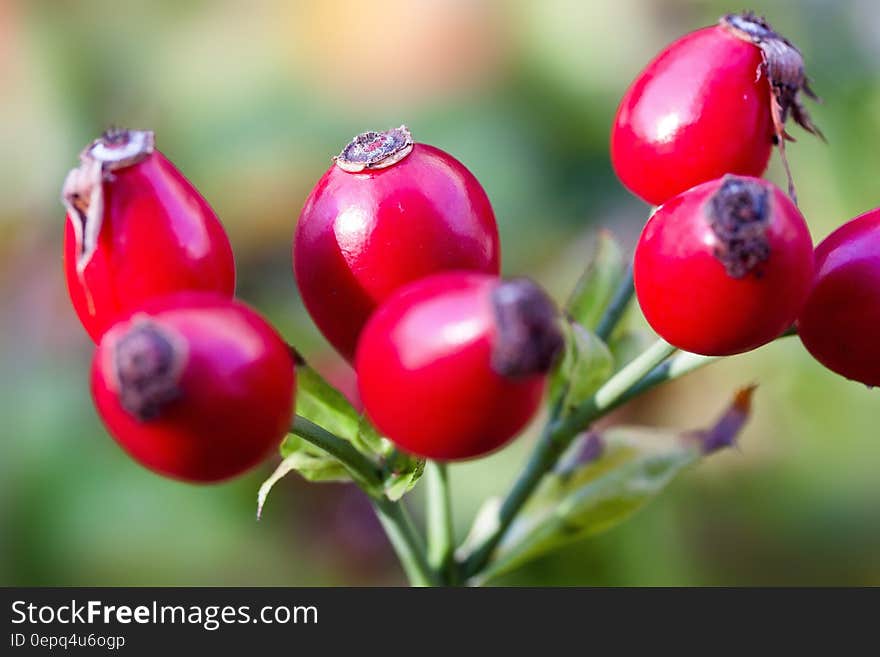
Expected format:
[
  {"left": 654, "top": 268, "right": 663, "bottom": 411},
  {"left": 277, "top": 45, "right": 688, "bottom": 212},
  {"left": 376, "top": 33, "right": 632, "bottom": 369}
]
[{"left": 113, "top": 319, "right": 185, "bottom": 422}]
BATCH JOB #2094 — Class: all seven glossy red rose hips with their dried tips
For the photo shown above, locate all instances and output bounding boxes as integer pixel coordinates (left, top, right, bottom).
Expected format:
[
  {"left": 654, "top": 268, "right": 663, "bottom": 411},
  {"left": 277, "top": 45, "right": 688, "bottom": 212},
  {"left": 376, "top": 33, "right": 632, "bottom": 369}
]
[{"left": 64, "top": 13, "right": 880, "bottom": 481}]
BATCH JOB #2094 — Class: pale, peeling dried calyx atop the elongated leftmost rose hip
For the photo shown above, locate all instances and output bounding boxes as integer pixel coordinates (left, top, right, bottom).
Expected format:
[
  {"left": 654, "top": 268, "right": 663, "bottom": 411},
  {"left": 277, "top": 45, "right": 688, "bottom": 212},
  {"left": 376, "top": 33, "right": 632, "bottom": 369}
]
[{"left": 61, "top": 128, "right": 155, "bottom": 275}]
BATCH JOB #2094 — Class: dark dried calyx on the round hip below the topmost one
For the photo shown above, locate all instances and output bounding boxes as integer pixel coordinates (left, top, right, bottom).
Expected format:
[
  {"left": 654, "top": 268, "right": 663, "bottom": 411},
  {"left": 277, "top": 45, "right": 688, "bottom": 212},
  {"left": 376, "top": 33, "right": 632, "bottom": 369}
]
[{"left": 706, "top": 176, "right": 770, "bottom": 278}]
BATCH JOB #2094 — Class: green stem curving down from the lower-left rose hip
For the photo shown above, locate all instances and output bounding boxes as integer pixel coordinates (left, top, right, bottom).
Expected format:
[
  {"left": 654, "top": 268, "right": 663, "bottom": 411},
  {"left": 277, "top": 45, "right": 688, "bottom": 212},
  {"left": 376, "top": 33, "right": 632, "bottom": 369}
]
[{"left": 291, "top": 415, "right": 441, "bottom": 586}]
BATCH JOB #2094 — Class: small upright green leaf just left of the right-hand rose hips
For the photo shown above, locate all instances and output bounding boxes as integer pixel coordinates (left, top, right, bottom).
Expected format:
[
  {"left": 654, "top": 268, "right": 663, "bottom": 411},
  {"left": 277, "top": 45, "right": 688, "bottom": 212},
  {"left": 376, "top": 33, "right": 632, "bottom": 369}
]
[{"left": 565, "top": 230, "right": 626, "bottom": 330}]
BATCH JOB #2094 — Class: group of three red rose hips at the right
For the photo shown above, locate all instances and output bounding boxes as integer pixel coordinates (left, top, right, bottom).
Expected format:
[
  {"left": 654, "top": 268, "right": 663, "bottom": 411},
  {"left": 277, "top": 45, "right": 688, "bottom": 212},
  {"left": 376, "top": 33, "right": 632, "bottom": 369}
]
[{"left": 611, "top": 13, "right": 880, "bottom": 386}]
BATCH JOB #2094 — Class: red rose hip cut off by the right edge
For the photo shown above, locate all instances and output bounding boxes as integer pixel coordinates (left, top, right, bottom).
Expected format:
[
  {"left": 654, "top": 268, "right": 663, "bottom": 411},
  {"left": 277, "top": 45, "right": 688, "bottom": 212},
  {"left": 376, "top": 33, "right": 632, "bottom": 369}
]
[{"left": 798, "top": 208, "right": 880, "bottom": 386}]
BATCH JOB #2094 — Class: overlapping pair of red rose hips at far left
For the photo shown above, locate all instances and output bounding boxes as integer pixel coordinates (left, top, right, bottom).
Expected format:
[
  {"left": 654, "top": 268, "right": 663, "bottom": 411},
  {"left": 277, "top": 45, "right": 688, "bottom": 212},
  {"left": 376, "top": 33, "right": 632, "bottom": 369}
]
[{"left": 63, "top": 130, "right": 295, "bottom": 482}]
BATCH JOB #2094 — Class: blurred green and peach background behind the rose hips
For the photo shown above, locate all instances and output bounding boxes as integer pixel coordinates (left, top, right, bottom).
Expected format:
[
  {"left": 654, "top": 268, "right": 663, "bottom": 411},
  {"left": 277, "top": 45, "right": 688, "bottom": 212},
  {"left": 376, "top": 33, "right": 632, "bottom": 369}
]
[{"left": 0, "top": 0, "right": 880, "bottom": 585}]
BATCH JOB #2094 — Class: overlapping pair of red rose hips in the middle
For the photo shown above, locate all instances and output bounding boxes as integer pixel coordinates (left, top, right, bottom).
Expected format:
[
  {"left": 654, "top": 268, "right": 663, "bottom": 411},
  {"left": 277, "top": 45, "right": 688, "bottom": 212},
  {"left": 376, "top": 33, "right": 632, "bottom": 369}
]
[{"left": 293, "top": 127, "right": 562, "bottom": 459}]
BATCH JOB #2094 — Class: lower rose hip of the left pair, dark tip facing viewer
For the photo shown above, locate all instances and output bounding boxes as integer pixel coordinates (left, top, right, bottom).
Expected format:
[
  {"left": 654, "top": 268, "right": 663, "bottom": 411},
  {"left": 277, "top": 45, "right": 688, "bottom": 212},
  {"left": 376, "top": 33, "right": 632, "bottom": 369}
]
[{"left": 92, "top": 292, "right": 295, "bottom": 482}]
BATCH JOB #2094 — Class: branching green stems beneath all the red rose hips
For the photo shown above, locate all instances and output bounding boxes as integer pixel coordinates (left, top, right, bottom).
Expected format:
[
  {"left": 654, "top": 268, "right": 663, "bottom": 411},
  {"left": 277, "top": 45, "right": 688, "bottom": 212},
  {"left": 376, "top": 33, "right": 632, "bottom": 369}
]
[{"left": 291, "top": 268, "right": 717, "bottom": 586}]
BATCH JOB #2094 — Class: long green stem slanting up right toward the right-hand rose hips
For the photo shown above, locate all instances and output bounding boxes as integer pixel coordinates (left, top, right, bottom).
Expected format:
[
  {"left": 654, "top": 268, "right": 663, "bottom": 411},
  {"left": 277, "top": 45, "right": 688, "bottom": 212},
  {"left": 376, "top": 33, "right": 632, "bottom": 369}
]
[{"left": 463, "top": 340, "right": 676, "bottom": 578}]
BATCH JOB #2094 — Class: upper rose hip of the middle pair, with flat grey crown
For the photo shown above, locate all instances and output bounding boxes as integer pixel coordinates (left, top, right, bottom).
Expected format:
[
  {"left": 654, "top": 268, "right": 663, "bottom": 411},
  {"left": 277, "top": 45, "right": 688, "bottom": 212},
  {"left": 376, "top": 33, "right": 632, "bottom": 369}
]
[{"left": 293, "top": 127, "right": 500, "bottom": 361}]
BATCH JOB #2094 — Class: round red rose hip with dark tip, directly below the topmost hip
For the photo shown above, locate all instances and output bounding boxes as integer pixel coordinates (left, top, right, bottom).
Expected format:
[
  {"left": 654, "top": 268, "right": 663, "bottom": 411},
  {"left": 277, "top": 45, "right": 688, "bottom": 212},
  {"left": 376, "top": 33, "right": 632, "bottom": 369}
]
[{"left": 634, "top": 176, "right": 813, "bottom": 356}]
